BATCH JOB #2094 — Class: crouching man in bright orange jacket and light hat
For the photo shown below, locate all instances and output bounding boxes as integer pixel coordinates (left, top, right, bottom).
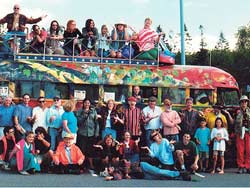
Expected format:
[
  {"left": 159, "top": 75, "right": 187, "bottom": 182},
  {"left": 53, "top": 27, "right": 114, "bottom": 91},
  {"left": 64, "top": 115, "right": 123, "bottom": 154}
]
[{"left": 51, "top": 133, "right": 85, "bottom": 174}]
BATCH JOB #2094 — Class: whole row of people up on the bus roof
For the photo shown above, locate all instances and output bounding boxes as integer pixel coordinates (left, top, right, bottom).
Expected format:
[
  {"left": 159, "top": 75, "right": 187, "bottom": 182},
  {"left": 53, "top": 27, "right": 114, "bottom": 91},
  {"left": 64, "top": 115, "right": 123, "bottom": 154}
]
[{"left": 0, "top": 4, "right": 162, "bottom": 59}]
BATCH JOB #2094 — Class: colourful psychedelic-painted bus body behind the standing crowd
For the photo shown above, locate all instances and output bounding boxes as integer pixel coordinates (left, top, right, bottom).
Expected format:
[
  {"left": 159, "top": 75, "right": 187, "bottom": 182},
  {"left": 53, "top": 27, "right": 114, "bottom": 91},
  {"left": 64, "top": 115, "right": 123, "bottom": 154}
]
[{"left": 0, "top": 53, "right": 239, "bottom": 109}]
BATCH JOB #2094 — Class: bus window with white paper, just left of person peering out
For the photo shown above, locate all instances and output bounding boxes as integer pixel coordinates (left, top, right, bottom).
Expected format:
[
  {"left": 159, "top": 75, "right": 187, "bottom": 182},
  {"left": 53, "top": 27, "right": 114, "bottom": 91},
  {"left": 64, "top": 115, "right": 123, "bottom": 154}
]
[{"left": 103, "top": 85, "right": 129, "bottom": 102}]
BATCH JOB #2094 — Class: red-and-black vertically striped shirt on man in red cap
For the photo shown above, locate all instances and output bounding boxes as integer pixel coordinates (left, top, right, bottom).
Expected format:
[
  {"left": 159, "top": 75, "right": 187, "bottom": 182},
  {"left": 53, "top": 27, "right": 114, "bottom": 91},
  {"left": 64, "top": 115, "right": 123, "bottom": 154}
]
[{"left": 125, "top": 107, "right": 142, "bottom": 136}]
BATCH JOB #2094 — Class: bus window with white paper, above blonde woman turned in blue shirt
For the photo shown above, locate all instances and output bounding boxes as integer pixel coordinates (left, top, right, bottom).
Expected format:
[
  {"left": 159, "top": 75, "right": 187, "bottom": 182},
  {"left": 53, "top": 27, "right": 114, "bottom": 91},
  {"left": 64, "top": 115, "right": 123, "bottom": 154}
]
[{"left": 70, "top": 84, "right": 99, "bottom": 101}]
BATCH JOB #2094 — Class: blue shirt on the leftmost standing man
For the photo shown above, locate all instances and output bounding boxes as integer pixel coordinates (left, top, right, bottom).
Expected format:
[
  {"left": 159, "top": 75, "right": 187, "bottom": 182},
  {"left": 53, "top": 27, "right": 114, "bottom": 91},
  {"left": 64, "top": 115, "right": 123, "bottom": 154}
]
[{"left": 0, "top": 105, "right": 15, "bottom": 127}]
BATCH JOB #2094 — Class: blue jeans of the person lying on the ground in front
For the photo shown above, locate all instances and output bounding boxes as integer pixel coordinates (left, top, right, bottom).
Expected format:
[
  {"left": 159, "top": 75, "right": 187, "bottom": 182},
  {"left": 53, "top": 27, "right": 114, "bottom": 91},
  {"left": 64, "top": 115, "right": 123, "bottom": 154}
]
[{"left": 140, "top": 162, "right": 180, "bottom": 179}]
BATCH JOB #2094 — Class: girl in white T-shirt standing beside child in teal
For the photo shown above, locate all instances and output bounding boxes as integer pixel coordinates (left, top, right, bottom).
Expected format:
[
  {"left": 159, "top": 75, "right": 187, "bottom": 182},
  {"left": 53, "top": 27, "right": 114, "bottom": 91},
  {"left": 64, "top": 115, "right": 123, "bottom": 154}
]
[{"left": 211, "top": 117, "right": 229, "bottom": 174}]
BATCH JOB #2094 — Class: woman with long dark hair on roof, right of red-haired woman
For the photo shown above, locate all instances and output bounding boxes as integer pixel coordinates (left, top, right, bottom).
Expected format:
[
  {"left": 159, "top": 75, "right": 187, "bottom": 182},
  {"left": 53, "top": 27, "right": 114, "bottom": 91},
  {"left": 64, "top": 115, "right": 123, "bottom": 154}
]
[{"left": 82, "top": 19, "right": 98, "bottom": 56}]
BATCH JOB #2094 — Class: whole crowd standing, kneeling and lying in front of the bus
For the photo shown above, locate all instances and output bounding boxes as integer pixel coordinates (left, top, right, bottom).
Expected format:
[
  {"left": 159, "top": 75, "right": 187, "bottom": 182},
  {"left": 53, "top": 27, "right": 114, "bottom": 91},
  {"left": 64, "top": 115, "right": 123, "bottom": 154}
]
[{"left": 0, "top": 86, "right": 250, "bottom": 180}]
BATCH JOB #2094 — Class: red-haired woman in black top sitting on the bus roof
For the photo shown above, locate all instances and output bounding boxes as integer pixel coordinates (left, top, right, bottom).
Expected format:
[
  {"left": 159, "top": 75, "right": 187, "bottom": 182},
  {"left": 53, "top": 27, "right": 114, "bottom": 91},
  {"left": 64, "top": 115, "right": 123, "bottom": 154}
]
[{"left": 63, "top": 20, "right": 83, "bottom": 56}]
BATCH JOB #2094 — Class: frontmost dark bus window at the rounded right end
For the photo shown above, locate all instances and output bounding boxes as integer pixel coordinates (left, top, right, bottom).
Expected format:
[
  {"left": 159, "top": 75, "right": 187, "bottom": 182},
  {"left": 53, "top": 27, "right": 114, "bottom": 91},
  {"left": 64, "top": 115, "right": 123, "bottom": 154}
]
[{"left": 217, "top": 88, "right": 239, "bottom": 106}]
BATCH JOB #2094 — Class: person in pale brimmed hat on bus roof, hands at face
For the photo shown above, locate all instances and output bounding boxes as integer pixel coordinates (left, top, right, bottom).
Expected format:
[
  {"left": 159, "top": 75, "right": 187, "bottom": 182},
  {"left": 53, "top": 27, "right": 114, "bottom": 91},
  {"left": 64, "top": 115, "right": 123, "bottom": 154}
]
[{"left": 110, "top": 21, "right": 129, "bottom": 58}]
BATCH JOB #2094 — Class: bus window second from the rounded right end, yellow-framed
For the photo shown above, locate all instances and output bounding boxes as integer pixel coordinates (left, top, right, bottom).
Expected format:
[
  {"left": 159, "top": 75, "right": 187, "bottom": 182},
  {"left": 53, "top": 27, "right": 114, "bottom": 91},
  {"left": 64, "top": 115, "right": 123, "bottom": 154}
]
[{"left": 190, "top": 89, "right": 212, "bottom": 105}]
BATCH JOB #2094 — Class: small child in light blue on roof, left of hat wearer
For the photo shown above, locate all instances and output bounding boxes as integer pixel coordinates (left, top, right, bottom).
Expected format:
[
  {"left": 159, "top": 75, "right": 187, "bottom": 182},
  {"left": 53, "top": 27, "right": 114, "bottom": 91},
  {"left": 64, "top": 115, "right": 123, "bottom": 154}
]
[{"left": 98, "top": 25, "right": 111, "bottom": 57}]
